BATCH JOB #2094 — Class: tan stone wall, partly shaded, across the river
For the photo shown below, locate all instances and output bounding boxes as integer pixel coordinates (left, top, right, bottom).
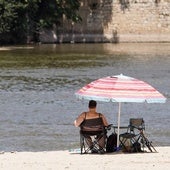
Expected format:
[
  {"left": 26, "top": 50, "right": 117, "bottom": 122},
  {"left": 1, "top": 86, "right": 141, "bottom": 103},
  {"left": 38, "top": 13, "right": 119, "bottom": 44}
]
[{"left": 41, "top": 0, "right": 170, "bottom": 43}]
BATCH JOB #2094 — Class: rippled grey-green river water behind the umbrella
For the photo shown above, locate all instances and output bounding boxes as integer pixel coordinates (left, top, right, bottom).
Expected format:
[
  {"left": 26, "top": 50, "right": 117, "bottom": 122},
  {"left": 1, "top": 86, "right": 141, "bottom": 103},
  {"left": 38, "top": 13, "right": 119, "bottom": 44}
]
[{"left": 0, "top": 43, "right": 170, "bottom": 151}]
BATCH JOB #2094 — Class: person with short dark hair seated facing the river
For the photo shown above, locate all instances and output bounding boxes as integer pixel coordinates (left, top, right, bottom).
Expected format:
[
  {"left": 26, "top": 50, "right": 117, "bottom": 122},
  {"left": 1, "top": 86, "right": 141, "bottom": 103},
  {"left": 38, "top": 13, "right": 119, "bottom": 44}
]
[{"left": 74, "top": 100, "right": 108, "bottom": 152}]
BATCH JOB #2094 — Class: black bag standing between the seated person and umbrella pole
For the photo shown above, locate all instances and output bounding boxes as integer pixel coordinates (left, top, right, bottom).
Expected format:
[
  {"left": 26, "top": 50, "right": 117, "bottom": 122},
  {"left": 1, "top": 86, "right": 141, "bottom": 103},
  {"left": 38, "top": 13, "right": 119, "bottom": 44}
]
[{"left": 106, "top": 133, "right": 117, "bottom": 152}]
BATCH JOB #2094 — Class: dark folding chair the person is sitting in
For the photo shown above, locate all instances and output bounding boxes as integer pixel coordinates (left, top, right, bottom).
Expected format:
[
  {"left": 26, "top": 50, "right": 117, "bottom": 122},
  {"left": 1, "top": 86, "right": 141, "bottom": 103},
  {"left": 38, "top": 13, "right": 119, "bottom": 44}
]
[{"left": 80, "top": 118, "right": 106, "bottom": 154}]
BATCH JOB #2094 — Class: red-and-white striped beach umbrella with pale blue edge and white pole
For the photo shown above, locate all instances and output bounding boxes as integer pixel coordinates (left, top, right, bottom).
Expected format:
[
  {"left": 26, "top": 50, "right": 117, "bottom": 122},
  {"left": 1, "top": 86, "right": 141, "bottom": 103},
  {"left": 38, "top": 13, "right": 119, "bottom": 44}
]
[{"left": 75, "top": 74, "right": 166, "bottom": 148}]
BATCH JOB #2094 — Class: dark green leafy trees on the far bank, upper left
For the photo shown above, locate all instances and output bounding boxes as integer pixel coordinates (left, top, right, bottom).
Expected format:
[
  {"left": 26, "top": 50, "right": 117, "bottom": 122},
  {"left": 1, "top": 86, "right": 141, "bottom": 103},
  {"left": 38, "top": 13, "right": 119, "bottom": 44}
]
[{"left": 0, "top": 0, "right": 81, "bottom": 44}]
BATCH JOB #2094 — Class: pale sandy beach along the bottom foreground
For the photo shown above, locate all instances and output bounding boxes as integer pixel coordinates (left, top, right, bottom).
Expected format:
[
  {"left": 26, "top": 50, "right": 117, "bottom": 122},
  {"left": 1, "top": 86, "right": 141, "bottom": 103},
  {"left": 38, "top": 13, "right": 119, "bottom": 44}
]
[{"left": 0, "top": 147, "right": 170, "bottom": 170}]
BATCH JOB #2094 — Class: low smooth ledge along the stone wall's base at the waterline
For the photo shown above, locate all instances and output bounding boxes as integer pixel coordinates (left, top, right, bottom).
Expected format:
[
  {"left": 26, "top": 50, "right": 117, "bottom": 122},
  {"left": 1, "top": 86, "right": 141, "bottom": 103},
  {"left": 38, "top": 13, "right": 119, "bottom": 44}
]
[{"left": 40, "top": 31, "right": 170, "bottom": 44}]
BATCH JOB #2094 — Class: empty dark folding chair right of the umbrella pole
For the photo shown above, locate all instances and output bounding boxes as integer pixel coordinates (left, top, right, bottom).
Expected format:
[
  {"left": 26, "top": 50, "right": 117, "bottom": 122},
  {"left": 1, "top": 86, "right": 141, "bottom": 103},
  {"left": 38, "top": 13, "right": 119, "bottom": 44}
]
[{"left": 119, "top": 118, "right": 157, "bottom": 152}]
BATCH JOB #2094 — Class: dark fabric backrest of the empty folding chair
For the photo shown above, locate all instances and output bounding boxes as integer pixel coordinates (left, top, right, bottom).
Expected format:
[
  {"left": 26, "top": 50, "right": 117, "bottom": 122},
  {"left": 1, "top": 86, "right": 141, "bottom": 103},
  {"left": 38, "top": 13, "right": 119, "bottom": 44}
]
[{"left": 129, "top": 118, "right": 145, "bottom": 131}]
